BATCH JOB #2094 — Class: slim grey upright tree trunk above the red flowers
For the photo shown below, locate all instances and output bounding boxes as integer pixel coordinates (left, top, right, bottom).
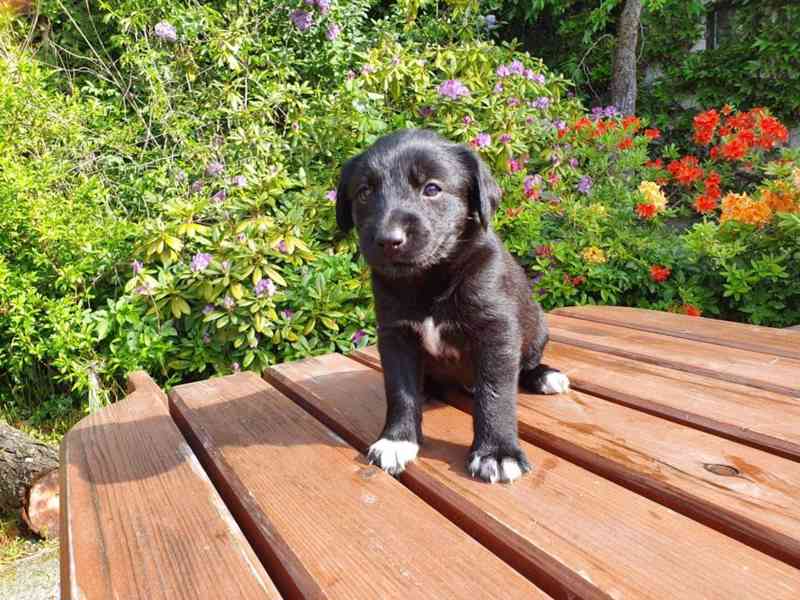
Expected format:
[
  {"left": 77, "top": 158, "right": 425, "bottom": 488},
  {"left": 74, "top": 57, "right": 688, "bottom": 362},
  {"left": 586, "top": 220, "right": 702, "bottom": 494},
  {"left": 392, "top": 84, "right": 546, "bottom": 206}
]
[{"left": 611, "top": 0, "right": 642, "bottom": 115}]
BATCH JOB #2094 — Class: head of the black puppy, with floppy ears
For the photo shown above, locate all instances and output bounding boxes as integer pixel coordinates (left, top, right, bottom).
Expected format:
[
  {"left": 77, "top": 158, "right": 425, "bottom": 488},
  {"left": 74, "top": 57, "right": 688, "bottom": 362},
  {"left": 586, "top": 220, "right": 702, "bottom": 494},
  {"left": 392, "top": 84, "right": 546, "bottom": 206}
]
[{"left": 336, "top": 129, "right": 501, "bottom": 277}]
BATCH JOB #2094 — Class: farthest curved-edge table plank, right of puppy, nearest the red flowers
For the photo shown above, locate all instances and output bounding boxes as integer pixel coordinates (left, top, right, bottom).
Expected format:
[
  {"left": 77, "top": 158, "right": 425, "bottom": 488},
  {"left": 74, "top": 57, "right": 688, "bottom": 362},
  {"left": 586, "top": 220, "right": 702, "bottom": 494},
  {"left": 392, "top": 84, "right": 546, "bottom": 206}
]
[{"left": 551, "top": 305, "right": 800, "bottom": 359}]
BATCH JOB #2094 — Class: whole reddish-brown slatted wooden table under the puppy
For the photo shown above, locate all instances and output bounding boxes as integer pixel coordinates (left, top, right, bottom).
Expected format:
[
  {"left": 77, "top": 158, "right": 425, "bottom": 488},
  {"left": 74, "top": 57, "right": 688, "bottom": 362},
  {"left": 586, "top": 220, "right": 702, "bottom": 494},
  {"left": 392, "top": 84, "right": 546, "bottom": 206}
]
[{"left": 61, "top": 307, "right": 800, "bottom": 600}]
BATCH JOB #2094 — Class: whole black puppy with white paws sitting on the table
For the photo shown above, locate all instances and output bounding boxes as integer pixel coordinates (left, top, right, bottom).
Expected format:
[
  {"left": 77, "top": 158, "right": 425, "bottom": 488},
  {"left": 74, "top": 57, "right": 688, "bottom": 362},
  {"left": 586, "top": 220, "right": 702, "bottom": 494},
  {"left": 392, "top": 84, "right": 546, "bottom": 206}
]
[{"left": 336, "top": 130, "right": 569, "bottom": 483}]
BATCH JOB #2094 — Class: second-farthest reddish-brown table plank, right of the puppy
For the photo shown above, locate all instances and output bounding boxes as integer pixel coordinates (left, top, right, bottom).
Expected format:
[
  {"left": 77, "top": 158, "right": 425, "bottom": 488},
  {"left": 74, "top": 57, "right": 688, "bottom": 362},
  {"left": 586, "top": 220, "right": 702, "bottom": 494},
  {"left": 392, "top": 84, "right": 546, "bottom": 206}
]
[{"left": 547, "top": 314, "right": 800, "bottom": 397}]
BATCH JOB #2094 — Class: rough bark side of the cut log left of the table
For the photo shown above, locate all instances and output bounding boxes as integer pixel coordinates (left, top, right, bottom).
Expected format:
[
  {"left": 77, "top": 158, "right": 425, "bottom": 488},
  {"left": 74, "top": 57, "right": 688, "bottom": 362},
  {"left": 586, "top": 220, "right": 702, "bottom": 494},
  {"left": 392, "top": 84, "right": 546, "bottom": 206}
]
[{"left": 0, "top": 423, "right": 58, "bottom": 513}]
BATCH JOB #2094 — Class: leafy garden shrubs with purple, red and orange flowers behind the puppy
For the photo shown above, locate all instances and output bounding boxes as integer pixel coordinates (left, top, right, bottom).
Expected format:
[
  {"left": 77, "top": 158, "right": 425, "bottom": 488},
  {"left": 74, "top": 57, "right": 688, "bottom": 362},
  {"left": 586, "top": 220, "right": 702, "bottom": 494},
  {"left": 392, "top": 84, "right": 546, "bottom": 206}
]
[{"left": 0, "top": 0, "right": 800, "bottom": 454}]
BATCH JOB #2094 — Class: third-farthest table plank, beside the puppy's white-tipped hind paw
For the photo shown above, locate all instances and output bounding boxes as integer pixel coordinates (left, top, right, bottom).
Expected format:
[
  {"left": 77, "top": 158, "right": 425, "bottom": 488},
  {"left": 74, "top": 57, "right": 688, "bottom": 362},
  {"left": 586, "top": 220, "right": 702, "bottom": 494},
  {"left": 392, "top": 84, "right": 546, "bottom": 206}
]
[{"left": 544, "top": 342, "right": 800, "bottom": 461}]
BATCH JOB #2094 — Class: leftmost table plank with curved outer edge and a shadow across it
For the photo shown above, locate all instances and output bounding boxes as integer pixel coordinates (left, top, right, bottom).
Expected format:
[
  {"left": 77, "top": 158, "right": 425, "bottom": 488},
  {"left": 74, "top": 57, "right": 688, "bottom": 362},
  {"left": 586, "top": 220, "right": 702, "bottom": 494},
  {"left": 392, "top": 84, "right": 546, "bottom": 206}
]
[{"left": 61, "top": 375, "right": 280, "bottom": 600}]
